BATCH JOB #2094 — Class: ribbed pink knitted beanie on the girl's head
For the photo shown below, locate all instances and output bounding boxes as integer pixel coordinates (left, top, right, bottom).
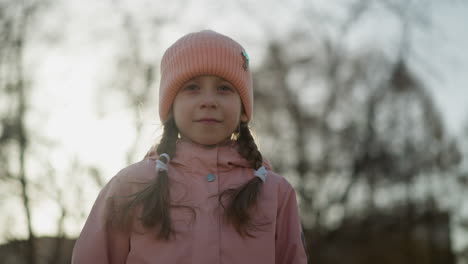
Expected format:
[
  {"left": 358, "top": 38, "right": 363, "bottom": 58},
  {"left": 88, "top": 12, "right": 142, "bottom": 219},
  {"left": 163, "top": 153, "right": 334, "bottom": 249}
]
[{"left": 159, "top": 30, "right": 253, "bottom": 122}]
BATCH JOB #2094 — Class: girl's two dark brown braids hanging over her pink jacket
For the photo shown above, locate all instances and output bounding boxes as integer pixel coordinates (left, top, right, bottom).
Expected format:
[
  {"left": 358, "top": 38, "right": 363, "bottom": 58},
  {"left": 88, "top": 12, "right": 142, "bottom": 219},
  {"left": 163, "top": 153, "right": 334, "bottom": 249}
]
[{"left": 110, "top": 118, "right": 263, "bottom": 240}]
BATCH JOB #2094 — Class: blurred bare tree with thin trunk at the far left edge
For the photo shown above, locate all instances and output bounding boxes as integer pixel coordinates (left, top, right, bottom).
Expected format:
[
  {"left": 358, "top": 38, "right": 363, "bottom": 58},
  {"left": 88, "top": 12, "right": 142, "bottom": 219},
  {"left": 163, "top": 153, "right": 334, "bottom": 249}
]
[{"left": 0, "top": 1, "right": 49, "bottom": 264}]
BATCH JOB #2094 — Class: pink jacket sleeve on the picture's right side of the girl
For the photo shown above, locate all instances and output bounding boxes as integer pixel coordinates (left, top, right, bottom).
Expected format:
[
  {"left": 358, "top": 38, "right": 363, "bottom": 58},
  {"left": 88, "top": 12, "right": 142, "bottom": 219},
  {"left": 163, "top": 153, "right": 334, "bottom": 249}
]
[{"left": 275, "top": 180, "right": 307, "bottom": 264}]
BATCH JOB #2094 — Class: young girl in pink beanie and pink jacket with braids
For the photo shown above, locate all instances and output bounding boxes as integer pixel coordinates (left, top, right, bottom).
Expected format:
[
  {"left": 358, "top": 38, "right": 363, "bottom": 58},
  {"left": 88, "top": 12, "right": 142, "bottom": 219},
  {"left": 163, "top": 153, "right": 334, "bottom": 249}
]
[{"left": 72, "top": 30, "right": 307, "bottom": 264}]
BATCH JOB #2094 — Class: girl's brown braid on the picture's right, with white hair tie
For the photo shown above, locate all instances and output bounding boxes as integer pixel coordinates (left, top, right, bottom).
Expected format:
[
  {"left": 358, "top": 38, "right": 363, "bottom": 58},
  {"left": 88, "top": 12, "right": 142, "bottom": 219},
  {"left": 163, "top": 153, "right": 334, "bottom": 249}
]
[{"left": 218, "top": 123, "right": 263, "bottom": 237}]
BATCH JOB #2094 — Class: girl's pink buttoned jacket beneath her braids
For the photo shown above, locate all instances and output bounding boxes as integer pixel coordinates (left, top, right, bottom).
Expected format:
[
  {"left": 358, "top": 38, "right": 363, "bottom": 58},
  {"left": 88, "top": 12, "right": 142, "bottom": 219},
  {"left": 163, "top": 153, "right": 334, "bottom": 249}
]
[{"left": 72, "top": 140, "right": 307, "bottom": 264}]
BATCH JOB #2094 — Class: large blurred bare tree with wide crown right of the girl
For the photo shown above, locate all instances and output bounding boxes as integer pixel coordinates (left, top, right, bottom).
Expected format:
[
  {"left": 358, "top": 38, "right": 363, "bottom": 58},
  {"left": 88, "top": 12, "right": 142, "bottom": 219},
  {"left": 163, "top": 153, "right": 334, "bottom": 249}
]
[{"left": 249, "top": 1, "right": 461, "bottom": 263}]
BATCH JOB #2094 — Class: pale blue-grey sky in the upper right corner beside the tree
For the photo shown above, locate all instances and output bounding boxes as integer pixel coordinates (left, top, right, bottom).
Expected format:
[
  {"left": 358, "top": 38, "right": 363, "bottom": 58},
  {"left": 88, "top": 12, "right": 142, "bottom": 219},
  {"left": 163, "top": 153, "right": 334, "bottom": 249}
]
[{"left": 414, "top": 1, "right": 468, "bottom": 134}]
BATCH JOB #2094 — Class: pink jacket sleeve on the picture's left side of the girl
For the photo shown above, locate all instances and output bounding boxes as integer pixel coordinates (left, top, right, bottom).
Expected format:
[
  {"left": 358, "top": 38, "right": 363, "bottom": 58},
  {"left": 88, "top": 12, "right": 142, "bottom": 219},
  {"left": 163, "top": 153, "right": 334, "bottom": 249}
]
[{"left": 72, "top": 173, "right": 130, "bottom": 264}]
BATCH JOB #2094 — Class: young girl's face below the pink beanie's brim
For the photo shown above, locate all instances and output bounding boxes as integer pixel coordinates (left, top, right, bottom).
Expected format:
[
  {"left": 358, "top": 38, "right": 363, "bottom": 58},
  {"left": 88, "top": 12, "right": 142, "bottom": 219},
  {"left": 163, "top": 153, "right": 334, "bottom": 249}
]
[{"left": 173, "top": 75, "right": 247, "bottom": 145}]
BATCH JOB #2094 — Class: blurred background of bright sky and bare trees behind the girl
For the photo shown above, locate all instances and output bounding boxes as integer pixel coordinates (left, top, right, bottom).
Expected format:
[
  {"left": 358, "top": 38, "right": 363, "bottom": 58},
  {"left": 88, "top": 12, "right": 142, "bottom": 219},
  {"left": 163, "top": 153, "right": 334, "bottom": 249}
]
[{"left": 0, "top": 0, "right": 468, "bottom": 264}]
